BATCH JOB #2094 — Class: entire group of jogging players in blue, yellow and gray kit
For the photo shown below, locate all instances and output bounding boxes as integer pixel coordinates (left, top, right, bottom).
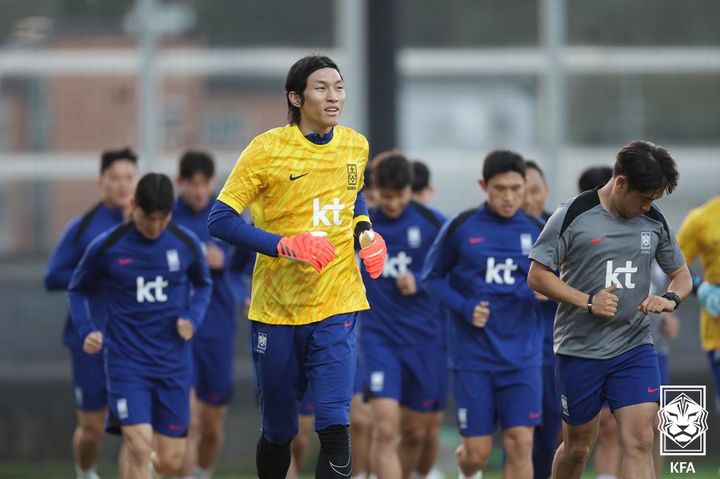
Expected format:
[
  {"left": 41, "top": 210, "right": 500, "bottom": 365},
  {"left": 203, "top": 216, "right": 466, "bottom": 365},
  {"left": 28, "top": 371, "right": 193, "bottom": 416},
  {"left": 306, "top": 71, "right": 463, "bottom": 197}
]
[{"left": 45, "top": 56, "right": 720, "bottom": 479}]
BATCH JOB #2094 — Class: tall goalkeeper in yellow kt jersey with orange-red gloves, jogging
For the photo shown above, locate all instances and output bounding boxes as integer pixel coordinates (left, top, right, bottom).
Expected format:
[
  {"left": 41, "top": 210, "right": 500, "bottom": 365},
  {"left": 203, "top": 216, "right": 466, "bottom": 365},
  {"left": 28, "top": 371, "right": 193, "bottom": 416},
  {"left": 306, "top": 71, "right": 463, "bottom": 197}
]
[{"left": 208, "top": 56, "right": 386, "bottom": 479}]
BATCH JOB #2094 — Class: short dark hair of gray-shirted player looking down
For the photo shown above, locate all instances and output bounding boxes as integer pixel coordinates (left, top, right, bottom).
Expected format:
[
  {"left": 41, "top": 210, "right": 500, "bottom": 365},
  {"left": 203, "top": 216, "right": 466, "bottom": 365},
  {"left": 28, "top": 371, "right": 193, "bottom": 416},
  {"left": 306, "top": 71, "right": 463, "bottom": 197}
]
[{"left": 613, "top": 140, "right": 680, "bottom": 194}]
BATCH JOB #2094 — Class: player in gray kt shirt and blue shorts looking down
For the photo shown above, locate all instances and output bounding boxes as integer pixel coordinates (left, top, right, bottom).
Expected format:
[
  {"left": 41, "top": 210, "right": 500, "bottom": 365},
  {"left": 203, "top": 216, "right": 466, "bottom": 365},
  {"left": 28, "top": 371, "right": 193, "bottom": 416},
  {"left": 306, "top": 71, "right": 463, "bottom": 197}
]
[{"left": 528, "top": 141, "right": 692, "bottom": 479}]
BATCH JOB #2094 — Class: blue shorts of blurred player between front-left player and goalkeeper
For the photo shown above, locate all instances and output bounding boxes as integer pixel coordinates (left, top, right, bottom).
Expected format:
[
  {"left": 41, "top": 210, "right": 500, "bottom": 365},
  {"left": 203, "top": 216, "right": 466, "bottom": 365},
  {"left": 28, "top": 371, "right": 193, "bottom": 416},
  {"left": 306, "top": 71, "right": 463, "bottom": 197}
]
[{"left": 192, "top": 335, "right": 235, "bottom": 406}]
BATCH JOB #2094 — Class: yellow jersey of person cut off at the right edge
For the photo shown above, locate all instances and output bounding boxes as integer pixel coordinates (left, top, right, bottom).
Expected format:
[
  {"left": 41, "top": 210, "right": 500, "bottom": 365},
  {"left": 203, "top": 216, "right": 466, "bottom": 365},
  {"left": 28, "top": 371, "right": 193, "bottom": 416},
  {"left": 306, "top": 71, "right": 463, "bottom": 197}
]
[{"left": 678, "top": 196, "right": 720, "bottom": 351}]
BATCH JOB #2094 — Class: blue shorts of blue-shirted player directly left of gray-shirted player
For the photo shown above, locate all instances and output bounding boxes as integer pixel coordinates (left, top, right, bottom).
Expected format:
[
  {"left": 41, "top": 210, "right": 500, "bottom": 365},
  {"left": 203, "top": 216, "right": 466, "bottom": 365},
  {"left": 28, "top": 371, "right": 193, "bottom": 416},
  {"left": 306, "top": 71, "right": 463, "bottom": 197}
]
[{"left": 453, "top": 366, "right": 542, "bottom": 437}]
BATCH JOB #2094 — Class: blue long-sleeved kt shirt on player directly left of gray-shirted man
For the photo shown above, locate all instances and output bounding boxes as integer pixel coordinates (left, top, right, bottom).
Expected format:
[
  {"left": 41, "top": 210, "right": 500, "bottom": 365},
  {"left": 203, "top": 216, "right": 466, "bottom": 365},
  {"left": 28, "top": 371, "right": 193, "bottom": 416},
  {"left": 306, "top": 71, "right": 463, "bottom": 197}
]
[{"left": 422, "top": 206, "right": 542, "bottom": 371}]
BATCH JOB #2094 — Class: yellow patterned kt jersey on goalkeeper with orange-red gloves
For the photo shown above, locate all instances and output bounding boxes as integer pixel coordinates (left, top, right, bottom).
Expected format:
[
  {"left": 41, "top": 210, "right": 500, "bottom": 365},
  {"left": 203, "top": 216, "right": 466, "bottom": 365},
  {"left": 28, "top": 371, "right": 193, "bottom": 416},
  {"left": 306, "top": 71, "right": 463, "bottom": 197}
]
[{"left": 218, "top": 125, "right": 369, "bottom": 325}]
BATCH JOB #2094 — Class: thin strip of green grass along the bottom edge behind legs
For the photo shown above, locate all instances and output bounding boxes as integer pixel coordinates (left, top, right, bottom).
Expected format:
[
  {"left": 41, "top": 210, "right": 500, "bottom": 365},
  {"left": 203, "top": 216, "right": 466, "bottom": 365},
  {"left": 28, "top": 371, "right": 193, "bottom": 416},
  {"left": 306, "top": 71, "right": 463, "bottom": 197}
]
[{"left": 0, "top": 462, "right": 720, "bottom": 479}]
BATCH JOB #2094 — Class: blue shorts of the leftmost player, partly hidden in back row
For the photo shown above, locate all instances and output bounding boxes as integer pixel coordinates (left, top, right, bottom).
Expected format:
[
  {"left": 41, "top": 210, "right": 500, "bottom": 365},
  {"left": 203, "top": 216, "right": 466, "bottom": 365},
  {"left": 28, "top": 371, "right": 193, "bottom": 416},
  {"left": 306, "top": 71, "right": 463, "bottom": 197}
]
[{"left": 69, "top": 346, "right": 107, "bottom": 412}]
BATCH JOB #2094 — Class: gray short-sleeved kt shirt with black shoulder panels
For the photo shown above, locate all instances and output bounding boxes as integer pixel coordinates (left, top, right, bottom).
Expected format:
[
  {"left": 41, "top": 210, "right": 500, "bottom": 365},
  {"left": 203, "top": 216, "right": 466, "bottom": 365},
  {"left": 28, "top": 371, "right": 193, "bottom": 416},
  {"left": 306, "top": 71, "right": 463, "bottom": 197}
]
[{"left": 530, "top": 190, "right": 685, "bottom": 359}]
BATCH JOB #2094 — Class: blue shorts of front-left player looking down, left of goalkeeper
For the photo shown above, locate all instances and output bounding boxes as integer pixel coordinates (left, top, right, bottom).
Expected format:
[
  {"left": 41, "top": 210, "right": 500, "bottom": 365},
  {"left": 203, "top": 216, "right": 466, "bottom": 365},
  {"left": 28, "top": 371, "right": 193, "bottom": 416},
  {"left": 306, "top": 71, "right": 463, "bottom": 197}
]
[{"left": 105, "top": 368, "right": 190, "bottom": 437}]
